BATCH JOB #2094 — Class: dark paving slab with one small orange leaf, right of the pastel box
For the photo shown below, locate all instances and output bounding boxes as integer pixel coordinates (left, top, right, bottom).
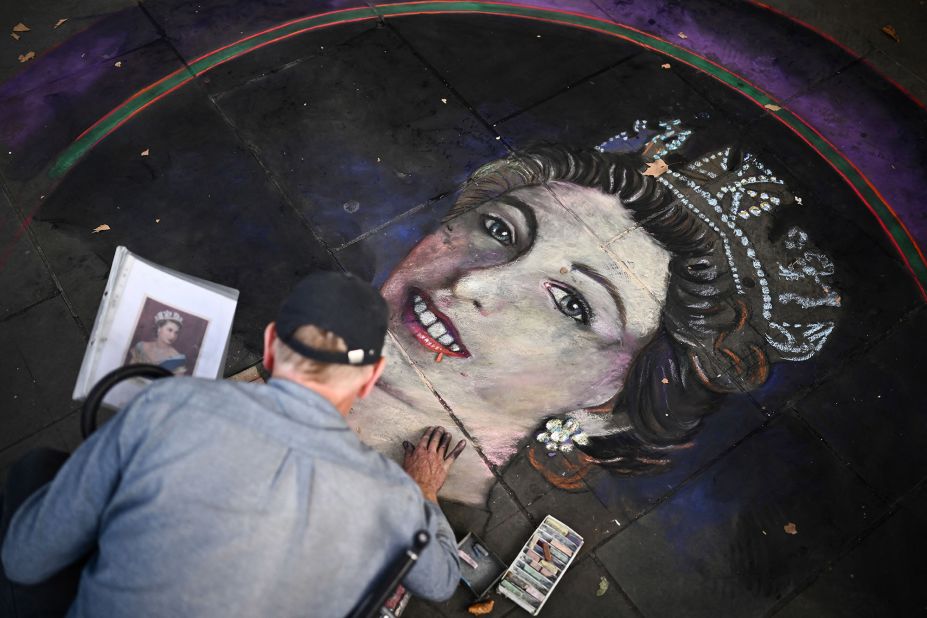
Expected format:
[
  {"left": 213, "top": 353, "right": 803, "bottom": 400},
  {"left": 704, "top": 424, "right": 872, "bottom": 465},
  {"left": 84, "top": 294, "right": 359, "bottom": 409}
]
[{"left": 597, "top": 416, "right": 885, "bottom": 616}]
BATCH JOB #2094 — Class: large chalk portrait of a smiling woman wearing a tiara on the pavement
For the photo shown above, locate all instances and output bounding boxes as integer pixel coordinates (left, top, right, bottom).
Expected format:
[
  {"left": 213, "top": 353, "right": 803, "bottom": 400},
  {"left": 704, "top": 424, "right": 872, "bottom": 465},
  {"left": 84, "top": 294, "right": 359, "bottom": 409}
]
[{"left": 349, "top": 127, "right": 840, "bottom": 503}]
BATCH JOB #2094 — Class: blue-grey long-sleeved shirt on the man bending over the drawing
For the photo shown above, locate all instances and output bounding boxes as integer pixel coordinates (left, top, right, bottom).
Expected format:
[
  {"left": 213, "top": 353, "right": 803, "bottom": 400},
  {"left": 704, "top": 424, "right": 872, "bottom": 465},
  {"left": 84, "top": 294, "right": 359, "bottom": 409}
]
[{"left": 2, "top": 378, "right": 459, "bottom": 618}]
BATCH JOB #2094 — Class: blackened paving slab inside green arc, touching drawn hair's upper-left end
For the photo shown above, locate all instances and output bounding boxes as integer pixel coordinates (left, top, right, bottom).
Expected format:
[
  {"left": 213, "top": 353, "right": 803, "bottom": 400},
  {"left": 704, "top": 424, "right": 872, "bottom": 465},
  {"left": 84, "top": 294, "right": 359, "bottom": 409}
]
[{"left": 211, "top": 24, "right": 504, "bottom": 248}]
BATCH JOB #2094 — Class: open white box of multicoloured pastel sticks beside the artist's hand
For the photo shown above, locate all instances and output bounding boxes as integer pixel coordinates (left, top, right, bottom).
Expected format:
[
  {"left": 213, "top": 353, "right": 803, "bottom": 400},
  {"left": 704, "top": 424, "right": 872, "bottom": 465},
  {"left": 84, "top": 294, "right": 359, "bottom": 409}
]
[{"left": 498, "top": 515, "right": 583, "bottom": 616}]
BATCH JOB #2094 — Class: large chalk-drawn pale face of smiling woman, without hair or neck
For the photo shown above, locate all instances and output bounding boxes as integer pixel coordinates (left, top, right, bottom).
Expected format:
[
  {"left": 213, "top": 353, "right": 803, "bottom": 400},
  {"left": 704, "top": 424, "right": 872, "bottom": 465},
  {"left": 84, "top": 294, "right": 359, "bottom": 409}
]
[{"left": 382, "top": 183, "right": 669, "bottom": 426}]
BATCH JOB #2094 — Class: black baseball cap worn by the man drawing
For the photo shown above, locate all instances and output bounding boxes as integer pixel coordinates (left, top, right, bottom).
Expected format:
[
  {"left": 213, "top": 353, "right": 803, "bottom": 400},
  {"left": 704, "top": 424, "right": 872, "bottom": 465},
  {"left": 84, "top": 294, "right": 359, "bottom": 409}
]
[{"left": 277, "top": 271, "right": 389, "bottom": 365}]
